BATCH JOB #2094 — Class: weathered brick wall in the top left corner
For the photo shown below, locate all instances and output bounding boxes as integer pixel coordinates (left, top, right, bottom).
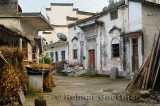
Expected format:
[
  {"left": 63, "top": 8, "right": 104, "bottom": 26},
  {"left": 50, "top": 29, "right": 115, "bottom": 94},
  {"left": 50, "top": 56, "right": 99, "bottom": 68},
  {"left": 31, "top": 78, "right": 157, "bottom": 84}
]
[{"left": 0, "top": 0, "right": 18, "bottom": 16}]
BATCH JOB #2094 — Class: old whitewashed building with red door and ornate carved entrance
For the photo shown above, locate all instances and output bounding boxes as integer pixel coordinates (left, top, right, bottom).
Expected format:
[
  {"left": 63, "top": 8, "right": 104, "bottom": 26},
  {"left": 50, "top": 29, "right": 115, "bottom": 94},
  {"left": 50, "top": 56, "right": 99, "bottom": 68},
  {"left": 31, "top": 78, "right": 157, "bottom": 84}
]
[{"left": 69, "top": 0, "right": 160, "bottom": 76}]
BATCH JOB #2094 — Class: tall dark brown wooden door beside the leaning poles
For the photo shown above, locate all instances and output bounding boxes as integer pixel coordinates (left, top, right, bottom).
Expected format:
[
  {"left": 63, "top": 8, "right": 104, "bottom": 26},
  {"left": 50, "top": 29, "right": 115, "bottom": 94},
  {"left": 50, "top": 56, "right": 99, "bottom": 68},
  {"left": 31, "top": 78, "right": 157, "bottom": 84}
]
[{"left": 132, "top": 38, "right": 139, "bottom": 72}]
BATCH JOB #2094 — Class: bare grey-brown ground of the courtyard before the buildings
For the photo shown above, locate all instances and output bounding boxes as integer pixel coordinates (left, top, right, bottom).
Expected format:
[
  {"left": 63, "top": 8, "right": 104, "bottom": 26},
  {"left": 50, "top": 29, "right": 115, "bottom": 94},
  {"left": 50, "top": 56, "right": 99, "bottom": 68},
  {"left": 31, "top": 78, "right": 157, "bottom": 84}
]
[{"left": 24, "top": 75, "right": 159, "bottom": 106}]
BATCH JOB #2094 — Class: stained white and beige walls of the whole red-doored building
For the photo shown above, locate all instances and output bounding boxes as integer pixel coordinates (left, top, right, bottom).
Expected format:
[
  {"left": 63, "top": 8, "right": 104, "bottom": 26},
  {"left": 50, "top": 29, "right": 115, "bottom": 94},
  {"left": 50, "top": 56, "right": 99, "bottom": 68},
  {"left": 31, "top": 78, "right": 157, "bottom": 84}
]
[{"left": 69, "top": 1, "right": 160, "bottom": 76}]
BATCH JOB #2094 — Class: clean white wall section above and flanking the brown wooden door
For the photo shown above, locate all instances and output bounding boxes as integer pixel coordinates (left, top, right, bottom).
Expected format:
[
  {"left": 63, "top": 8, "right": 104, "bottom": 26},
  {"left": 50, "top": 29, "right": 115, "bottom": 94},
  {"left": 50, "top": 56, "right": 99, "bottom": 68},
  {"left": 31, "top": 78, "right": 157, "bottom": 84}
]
[{"left": 128, "top": 1, "right": 143, "bottom": 73}]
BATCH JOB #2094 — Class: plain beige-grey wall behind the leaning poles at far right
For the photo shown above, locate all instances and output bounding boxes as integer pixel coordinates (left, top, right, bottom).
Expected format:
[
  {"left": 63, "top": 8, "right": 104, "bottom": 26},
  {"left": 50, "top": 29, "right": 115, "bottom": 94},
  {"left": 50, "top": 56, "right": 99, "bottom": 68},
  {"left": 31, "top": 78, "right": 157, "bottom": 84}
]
[{"left": 142, "top": 4, "right": 160, "bottom": 60}]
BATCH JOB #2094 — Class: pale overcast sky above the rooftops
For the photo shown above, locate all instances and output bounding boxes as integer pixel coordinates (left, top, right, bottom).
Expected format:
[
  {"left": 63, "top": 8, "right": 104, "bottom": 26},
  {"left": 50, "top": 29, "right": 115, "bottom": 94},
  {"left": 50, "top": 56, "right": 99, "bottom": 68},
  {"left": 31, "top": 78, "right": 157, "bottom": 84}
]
[{"left": 19, "top": 0, "right": 108, "bottom": 15}]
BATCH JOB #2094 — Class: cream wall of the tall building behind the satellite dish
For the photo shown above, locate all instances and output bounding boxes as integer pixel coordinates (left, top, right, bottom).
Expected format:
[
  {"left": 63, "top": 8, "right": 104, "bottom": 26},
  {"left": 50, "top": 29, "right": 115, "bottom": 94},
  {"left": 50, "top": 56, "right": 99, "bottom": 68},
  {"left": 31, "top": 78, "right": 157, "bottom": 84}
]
[{"left": 43, "top": 5, "right": 77, "bottom": 44}]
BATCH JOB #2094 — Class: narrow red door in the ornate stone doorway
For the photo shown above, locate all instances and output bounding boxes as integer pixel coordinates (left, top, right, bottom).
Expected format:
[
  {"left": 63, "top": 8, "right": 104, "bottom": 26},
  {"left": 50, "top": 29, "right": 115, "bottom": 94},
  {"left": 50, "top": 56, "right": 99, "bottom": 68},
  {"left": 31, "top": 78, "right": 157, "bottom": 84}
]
[{"left": 89, "top": 50, "right": 95, "bottom": 71}]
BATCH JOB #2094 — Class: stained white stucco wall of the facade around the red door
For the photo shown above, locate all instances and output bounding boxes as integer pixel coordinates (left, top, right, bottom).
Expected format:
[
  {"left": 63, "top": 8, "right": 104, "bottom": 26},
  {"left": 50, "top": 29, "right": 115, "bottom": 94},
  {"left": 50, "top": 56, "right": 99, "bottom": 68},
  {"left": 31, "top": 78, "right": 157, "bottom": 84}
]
[{"left": 69, "top": 7, "right": 129, "bottom": 74}]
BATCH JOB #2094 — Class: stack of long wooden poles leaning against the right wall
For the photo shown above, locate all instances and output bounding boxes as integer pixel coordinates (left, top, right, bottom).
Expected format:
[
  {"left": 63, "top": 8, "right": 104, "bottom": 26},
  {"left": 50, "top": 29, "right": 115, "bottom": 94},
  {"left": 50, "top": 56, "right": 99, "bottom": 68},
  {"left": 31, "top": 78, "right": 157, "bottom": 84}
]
[{"left": 127, "top": 34, "right": 160, "bottom": 90}]
